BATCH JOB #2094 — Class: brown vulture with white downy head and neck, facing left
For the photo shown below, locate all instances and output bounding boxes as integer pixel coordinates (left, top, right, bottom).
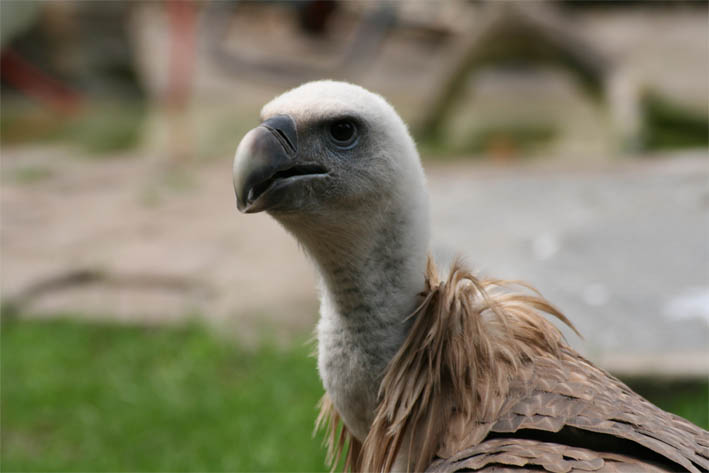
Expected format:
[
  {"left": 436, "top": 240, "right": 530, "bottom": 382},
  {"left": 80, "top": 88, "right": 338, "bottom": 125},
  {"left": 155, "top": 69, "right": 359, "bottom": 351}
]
[{"left": 233, "top": 81, "right": 709, "bottom": 473}]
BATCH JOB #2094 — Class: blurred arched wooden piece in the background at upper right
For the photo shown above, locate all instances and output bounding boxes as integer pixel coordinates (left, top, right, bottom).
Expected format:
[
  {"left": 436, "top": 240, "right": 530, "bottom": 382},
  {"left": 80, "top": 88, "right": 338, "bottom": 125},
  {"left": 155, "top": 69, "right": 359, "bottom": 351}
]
[{"left": 417, "top": 2, "right": 641, "bottom": 155}]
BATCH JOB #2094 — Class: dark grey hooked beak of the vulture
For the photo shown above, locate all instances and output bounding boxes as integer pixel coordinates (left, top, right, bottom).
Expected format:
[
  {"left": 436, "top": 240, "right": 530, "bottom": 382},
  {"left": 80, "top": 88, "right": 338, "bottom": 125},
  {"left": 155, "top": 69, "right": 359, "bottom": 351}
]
[{"left": 233, "top": 115, "right": 327, "bottom": 213}]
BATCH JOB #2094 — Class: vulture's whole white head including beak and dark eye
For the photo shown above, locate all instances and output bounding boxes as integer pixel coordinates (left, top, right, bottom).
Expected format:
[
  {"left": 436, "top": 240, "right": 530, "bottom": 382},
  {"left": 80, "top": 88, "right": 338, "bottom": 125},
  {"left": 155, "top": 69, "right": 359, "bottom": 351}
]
[{"left": 234, "top": 81, "right": 425, "bottom": 216}]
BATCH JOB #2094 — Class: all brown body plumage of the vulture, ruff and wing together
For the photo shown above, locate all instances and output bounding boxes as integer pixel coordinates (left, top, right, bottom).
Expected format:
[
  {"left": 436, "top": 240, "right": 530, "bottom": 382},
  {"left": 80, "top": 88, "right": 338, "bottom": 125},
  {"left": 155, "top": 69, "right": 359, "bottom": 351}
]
[{"left": 321, "top": 261, "right": 709, "bottom": 472}]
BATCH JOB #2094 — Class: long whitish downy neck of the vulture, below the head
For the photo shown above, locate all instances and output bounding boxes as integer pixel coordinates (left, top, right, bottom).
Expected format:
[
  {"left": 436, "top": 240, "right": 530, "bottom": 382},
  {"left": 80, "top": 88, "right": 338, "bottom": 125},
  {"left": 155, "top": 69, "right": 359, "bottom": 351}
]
[{"left": 274, "top": 203, "right": 428, "bottom": 440}]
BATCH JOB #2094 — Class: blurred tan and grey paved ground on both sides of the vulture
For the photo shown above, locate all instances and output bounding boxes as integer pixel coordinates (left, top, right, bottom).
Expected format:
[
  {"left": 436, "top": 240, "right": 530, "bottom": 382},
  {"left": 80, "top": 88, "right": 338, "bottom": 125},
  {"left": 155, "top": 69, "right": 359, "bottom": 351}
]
[{"left": 0, "top": 148, "right": 709, "bottom": 375}]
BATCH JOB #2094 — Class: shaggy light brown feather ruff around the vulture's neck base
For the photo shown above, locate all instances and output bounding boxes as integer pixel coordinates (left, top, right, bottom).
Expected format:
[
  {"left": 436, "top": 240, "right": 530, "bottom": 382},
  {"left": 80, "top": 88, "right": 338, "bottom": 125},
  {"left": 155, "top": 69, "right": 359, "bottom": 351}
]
[{"left": 316, "top": 258, "right": 578, "bottom": 471}]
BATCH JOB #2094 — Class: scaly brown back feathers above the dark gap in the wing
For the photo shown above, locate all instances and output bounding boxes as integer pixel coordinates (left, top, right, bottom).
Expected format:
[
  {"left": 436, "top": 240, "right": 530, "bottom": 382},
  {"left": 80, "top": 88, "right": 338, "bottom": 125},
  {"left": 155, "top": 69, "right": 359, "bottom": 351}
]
[{"left": 476, "top": 347, "right": 709, "bottom": 471}]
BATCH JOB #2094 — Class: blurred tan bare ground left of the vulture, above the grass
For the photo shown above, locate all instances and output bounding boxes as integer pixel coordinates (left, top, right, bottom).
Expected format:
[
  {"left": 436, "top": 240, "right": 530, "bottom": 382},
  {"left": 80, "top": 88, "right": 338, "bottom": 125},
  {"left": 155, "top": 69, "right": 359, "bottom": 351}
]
[{"left": 2, "top": 148, "right": 316, "bottom": 338}]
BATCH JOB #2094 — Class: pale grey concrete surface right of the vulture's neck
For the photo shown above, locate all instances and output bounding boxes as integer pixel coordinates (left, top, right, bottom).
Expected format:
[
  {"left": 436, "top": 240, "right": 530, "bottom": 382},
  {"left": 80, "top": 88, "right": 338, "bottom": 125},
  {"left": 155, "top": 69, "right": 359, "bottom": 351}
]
[{"left": 429, "top": 154, "right": 709, "bottom": 375}]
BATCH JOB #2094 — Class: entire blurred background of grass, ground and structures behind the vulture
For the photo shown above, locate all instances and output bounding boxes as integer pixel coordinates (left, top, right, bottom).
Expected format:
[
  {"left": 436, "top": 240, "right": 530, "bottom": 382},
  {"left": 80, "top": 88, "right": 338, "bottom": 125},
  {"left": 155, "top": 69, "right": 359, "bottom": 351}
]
[{"left": 0, "top": 0, "right": 709, "bottom": 471}]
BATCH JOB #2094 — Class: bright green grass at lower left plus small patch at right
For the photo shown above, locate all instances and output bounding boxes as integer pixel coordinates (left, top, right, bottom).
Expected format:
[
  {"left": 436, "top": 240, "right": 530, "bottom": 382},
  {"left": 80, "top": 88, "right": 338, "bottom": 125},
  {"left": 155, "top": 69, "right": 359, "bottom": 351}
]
[{"left": 0, "top": 319, "right": 709, "bottom": 471}]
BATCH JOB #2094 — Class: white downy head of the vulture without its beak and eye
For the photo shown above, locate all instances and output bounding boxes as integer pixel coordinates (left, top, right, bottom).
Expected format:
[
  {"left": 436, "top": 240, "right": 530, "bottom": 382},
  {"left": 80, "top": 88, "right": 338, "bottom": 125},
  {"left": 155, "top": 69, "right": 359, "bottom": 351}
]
[{"left": 261, "top": 80, "right": 428, "bottom": 223}]
